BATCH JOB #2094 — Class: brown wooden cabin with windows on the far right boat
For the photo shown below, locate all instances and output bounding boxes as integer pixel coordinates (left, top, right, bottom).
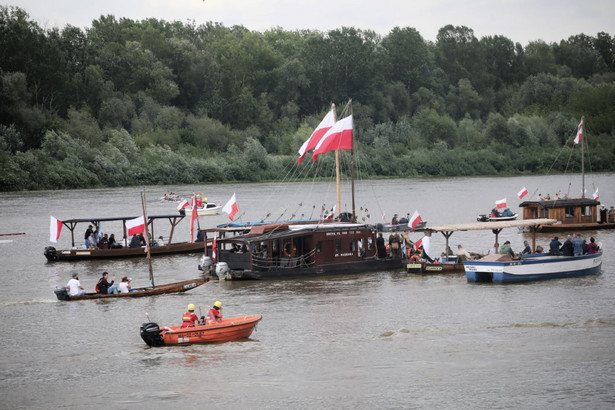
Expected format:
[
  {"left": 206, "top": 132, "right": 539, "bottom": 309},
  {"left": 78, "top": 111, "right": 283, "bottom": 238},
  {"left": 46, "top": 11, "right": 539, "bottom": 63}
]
[{"left": 519, "top": 198, "right": 600, "bottom": 229}]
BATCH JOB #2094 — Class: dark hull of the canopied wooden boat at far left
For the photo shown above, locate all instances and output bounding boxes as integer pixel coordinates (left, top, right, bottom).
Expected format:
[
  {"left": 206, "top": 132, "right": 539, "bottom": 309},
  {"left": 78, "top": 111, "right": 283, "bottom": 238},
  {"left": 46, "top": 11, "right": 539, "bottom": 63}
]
[{"left": 44, "top": 242, "right": 204, "bottom": 262}]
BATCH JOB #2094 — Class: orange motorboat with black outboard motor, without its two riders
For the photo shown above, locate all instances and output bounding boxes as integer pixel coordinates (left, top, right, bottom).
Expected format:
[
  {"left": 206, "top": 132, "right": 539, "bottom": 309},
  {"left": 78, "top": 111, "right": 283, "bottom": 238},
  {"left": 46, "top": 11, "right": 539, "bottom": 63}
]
[{"left": 141, "top": 315, "right": 263, "bottom": 347}]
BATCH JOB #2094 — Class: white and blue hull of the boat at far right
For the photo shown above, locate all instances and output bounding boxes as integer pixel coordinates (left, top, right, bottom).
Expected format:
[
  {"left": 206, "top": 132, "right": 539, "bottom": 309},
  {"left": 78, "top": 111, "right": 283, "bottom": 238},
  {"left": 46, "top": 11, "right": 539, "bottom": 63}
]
[{"left": 463, "top": 251, "right": 602, "bottom": 283}]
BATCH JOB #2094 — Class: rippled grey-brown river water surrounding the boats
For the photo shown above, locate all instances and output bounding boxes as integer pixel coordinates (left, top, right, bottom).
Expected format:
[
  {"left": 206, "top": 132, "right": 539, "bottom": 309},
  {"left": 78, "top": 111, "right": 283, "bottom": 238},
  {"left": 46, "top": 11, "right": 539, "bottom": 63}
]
[{"left": 0, "top": 174, "right": 615, "bottom": 409}]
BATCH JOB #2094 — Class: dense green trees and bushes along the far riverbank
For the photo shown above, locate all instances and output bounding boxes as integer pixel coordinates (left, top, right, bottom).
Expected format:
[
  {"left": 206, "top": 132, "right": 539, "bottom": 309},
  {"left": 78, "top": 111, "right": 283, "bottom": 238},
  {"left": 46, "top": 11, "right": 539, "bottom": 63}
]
[{"left": 0, "top": 6, "right": 615, "bottom": 192}]
